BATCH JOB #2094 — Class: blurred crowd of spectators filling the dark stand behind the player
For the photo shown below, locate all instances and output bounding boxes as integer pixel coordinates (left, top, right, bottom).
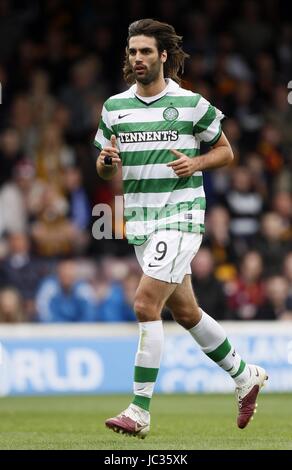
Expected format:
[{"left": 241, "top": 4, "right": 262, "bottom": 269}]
[{"left": 0, "top": 0, "right": 292, "bottom": 323}]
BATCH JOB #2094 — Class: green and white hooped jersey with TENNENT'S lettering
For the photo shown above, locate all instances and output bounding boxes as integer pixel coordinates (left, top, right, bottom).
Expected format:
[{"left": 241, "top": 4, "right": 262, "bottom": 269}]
[{"left": 94, "top": 79, "right": 224, "bottom": 245}]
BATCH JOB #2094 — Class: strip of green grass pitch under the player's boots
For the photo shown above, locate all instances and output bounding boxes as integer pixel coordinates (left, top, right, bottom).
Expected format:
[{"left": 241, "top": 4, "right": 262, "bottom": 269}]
[{"left": 0, "top": 394, "right": 292, "bottom": 450}]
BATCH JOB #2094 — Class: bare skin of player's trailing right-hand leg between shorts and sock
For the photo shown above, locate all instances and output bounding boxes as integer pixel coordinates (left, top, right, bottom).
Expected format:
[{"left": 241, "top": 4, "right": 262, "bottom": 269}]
[{"left": 166, "top": 274, "right": 200, "bottom": 320}]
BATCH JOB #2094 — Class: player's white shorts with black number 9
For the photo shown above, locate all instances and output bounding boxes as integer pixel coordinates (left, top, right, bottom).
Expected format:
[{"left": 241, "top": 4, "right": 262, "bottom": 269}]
[{"left": 135, "top": 230, "right": 203, "bottom": 284}]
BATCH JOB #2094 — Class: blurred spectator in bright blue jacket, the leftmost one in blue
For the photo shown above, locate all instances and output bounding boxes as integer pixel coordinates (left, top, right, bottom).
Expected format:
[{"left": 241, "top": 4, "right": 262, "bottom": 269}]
[{"left": 36, "top": 260, "right": 96, "bottom": 323}]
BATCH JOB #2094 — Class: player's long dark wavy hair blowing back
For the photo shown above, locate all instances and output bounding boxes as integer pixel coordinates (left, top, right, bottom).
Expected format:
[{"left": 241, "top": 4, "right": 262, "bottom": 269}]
[{"left": 123, "top": 18, "right": 189, "bottom": 85}]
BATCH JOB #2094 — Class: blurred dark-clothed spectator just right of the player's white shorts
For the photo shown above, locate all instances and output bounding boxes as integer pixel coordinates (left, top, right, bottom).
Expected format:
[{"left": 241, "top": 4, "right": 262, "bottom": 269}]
[{"left": 191, "top": 248, "right": 227, "bottom": 320}]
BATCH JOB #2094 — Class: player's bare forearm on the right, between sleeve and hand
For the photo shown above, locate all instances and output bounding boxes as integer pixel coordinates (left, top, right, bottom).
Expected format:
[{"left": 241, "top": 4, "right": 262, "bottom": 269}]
[{"left": 194, "top": 145, "right": 234, "bottom": 171}]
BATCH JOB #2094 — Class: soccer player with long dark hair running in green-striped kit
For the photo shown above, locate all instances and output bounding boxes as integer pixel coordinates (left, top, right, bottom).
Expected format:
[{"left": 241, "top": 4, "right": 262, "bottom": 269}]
[{"left": 95, "top": 19, "right": 268, "bottom": 438}]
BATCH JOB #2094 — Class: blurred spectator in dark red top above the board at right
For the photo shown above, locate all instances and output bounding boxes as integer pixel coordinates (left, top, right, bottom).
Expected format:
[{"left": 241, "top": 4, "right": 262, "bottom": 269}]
[{"left": 226, "top": 251, "right": 265, "bottom": 320}]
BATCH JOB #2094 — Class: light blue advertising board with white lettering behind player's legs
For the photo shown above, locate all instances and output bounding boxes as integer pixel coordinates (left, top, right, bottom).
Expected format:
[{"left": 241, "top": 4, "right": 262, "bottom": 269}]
[{"left": 0, "top": 334, "right": 292, "bottom": 396}]
